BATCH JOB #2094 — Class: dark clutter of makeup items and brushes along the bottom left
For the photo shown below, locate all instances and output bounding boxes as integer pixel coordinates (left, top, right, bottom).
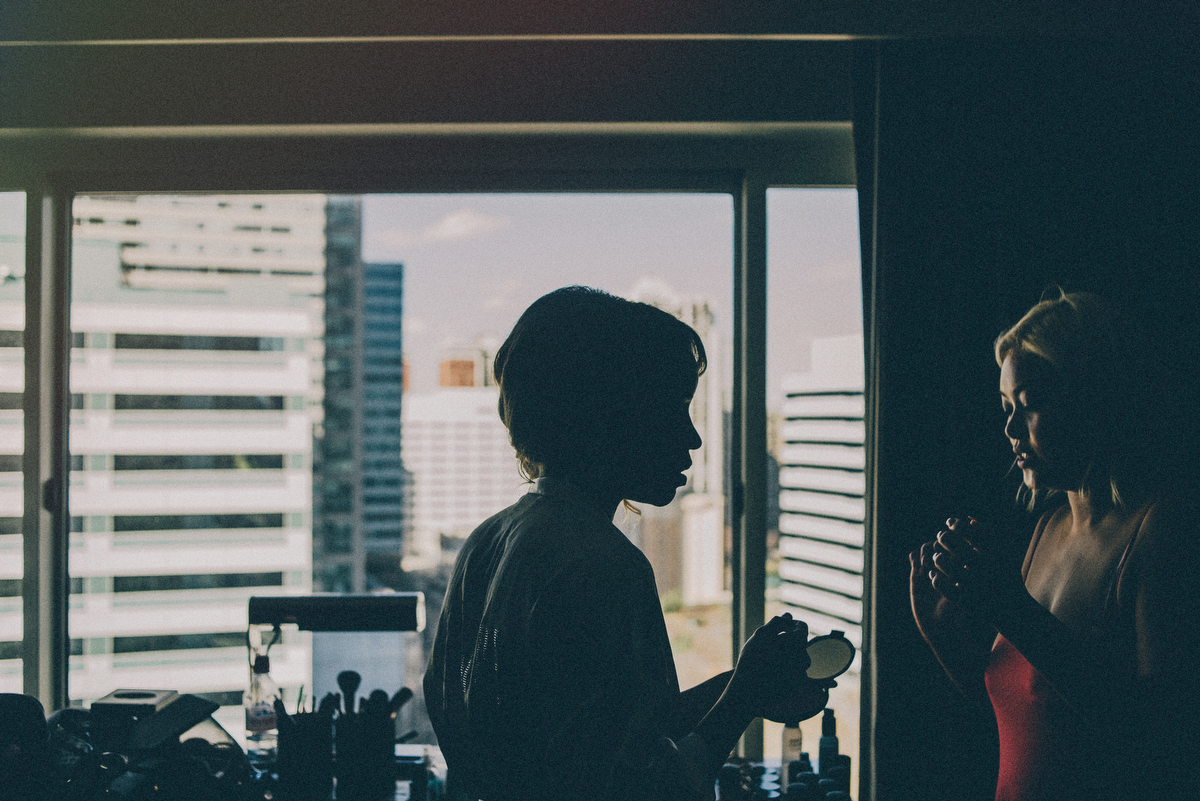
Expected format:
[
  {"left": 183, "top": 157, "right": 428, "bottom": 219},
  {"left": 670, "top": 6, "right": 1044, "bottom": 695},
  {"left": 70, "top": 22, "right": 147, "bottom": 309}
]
[{"left": 0, "top": 670, "right": 444, "bottom": 801}]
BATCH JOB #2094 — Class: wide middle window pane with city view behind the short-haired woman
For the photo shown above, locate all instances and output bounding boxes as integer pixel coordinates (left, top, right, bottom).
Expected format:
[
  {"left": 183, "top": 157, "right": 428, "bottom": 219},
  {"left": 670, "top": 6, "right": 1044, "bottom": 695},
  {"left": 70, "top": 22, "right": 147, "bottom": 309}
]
[{"left": 68, "top": 193, "right": 733, "bottom": 737}]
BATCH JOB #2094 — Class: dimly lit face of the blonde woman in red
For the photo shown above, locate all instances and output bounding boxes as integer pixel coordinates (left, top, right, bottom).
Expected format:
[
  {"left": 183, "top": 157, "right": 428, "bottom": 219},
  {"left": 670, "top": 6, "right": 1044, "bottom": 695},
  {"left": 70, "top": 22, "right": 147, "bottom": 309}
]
[{"left": 1000, "top": 351, "right": 1087, "bottom": 490}]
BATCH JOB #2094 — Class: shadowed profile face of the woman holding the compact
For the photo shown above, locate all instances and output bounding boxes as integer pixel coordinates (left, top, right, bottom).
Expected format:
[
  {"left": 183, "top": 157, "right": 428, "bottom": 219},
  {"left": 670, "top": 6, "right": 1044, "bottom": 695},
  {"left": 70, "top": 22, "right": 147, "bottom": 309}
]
[{"left": 619, "top": 388, "right": 701, "bottom": 506}]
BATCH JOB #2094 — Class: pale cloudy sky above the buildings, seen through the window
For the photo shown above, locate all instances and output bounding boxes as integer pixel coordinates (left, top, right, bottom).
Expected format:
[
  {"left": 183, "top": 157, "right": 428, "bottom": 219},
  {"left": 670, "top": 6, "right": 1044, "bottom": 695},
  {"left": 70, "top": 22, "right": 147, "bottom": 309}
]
[{"left": 0, "top": 188, "right": 862, "bottom": 406}]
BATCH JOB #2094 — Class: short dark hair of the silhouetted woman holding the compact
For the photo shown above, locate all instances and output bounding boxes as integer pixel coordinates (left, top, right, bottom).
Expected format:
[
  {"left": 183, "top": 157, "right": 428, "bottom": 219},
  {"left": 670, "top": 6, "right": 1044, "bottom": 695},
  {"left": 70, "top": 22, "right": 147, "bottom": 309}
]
[{"left": 493, "top": 287, "right": 707, "bottom": 480}]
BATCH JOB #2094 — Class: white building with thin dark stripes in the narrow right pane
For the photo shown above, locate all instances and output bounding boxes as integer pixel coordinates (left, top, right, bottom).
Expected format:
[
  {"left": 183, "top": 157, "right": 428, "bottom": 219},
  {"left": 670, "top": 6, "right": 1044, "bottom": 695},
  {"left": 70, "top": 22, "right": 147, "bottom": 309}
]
[{"left": 779, "top": 335, "right": 865, "bottom": 649}]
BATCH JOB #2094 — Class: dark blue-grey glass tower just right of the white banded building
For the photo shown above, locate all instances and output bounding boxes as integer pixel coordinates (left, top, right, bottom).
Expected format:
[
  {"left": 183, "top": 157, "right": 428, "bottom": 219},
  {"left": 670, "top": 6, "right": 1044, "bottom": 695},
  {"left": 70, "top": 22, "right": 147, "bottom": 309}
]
[{"left": 313, "top": 197, "right": 408, "bottom": 592}]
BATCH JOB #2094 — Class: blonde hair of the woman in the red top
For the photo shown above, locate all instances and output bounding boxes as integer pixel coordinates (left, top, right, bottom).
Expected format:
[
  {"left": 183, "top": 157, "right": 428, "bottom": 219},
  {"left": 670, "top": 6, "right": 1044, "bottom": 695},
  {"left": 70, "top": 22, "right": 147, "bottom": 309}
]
[{"left": 995, "top": 290, "right": 1151, "bottom": 507}]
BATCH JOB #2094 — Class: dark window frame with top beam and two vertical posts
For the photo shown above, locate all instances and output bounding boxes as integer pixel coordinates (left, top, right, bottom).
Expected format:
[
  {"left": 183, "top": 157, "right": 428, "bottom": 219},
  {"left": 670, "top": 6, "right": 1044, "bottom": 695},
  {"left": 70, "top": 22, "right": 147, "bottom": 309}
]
[{"left": 9, "top": 122, "right": 854, "bottom": 758}]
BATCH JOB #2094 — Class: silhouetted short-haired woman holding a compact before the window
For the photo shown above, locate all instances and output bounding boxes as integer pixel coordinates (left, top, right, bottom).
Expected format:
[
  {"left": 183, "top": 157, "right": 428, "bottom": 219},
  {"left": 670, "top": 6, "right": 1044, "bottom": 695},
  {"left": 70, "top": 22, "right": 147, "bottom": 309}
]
[{"left": 425, "top": 287, "right": 824, "bottom": 801}]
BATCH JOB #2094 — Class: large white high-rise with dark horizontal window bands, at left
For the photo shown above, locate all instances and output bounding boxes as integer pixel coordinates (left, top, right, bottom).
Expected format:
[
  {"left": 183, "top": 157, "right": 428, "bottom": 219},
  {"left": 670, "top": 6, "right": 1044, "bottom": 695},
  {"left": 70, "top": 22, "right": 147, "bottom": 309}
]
[{"left": 10, "top": 190, "right": 325, "bottom": 714}]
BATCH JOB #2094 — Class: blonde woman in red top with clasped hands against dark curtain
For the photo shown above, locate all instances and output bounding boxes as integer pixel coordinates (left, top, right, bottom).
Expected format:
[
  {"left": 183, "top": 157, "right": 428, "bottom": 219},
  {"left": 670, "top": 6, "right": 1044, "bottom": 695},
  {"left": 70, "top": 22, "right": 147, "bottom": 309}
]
[{"left": 910, "top": 294, "right": 1200, "bottom": 801}]
